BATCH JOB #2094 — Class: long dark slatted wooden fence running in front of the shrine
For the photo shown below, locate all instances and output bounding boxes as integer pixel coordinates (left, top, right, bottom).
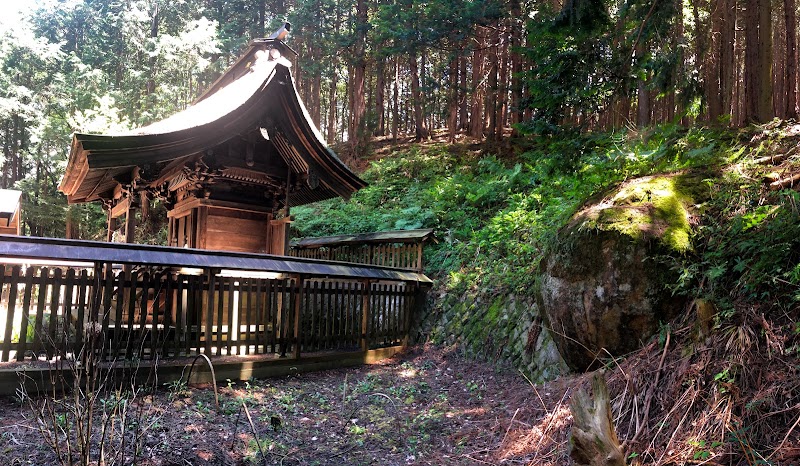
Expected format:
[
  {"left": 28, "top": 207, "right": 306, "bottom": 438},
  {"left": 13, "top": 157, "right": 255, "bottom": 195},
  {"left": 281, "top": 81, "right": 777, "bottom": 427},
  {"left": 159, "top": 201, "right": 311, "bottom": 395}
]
[{"left": 0, "top": 239, "right": 428, "bottom": 361}]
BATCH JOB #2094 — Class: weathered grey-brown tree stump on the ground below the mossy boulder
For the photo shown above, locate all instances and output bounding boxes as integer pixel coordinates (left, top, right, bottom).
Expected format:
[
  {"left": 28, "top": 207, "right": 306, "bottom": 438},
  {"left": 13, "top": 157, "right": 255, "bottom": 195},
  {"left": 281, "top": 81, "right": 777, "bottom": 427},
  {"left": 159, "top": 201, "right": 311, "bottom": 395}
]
[{"left": 569, "top": 371, "right": 625, "bottom": 466}]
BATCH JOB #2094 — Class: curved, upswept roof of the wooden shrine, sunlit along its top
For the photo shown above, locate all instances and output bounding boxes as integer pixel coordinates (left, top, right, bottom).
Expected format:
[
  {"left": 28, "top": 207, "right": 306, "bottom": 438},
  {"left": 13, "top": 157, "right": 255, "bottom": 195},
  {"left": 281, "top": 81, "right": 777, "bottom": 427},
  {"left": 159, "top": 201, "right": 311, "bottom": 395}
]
[{"left": 59, "top": 40, "right": 366, "bottom": 206}]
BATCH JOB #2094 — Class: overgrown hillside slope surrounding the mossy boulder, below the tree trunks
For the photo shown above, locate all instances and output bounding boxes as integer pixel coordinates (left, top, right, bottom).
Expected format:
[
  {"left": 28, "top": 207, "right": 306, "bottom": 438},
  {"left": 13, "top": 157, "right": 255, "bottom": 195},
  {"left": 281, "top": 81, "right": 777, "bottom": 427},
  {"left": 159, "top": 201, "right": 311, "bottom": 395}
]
[{"left": 295, "top": 124, "right": 800, "bottom": 464}]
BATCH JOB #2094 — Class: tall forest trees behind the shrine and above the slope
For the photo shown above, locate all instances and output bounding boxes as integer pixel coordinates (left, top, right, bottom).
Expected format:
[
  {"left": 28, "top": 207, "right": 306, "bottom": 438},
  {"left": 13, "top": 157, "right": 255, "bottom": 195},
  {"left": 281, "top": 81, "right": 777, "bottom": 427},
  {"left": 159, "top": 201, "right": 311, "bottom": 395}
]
[{"left": 0, "top": 0, "right": 797, "bottom": 238}]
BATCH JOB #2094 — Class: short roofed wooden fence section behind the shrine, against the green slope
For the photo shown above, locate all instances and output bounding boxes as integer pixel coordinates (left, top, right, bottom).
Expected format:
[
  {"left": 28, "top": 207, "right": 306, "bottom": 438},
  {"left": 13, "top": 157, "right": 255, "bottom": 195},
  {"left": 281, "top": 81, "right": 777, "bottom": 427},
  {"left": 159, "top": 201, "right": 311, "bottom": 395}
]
[{"left": 289, "top": 229, "right": 435, "bottom": 273}]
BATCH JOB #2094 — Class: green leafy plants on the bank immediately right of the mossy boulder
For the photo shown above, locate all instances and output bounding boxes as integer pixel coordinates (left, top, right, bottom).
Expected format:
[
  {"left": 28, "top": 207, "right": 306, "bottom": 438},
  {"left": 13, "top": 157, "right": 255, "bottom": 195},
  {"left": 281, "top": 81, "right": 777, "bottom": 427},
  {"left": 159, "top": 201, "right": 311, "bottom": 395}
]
[{"left": 683, "top": 186, "right": 800, "bottom": 314}]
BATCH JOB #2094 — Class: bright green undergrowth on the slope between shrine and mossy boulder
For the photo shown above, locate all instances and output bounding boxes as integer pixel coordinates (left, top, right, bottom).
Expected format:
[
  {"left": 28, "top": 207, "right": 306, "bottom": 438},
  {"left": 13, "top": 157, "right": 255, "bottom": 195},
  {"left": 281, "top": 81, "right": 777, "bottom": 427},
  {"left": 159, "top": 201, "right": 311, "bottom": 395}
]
[{"left": 293, "top": 126, "right": 732, "bottom": 294}]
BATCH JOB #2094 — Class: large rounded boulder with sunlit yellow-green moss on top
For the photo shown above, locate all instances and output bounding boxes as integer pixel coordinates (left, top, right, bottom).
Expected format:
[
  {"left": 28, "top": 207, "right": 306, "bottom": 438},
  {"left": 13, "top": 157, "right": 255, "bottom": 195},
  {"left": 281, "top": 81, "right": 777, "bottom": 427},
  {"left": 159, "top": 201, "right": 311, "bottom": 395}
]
[{"left": 540, "top": 173, "right": 707, "bottom": 371}]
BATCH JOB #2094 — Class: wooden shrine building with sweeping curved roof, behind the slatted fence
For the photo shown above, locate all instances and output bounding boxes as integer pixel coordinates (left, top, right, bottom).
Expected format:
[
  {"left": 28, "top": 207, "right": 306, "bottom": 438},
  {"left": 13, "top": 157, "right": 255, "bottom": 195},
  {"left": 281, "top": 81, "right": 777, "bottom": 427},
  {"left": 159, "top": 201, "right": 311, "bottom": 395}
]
[{"left": 59, "top": 30, "right": 366, "bottom": 255}]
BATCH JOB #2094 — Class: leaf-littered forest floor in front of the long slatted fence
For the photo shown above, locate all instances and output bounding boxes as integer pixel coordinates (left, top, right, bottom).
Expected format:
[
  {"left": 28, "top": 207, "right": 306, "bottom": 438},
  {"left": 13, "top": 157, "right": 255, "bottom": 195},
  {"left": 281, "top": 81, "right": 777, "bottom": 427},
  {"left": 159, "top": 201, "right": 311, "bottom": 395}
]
[{"left": 0, "top": 347, "right": 582, "bottom": 465}]
